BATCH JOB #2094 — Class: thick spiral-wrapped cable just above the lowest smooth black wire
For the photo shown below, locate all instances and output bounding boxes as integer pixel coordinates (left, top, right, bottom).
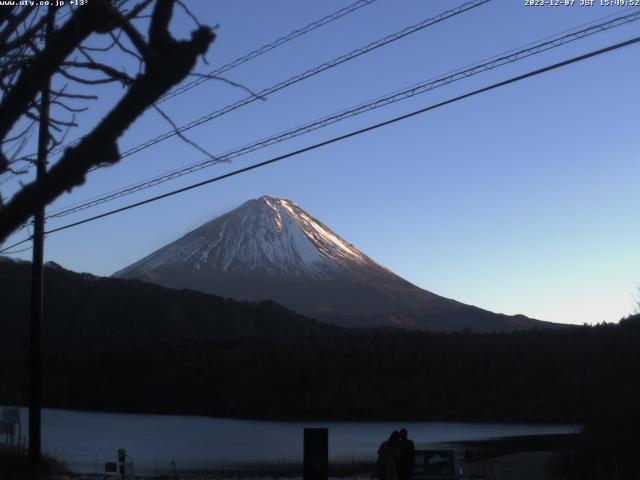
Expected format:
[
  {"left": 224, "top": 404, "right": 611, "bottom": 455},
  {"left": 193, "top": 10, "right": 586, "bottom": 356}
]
[{"left": 47, "top": 11, "right": 640, "bottom": 219}]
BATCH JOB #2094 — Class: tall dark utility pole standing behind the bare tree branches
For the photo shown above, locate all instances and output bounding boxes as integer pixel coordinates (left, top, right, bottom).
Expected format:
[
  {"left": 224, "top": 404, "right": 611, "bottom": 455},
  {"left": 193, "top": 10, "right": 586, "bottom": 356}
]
[{"left": 29, "top": 6, "right": 55, "bottom": 480}]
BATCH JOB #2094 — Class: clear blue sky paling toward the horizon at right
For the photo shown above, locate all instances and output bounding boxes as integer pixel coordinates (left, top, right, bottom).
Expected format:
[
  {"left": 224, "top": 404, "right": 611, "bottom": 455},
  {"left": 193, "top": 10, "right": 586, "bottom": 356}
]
[{"left": 1, "top": 0, "right": 640, "bottom": 323}]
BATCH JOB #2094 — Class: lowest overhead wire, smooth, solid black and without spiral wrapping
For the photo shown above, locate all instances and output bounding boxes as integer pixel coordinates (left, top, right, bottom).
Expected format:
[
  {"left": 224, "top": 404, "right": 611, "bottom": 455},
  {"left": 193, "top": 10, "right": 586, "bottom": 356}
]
[{"left": 0, "top": 36, "right": 640, "bottom": 253}]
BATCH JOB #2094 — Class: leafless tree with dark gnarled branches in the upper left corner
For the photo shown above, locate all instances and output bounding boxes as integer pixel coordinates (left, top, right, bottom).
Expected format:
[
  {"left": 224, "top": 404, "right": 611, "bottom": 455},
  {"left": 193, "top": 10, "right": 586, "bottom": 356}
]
[{"left": 0, "top": 0, "right": 215, "bottom": 244}]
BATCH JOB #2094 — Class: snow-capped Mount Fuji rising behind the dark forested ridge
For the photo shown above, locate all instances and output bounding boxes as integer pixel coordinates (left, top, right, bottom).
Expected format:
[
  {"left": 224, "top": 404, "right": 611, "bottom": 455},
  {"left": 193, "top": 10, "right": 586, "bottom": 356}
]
[{"left": 114, "top": 196, "right": 553, "bottom": 331}]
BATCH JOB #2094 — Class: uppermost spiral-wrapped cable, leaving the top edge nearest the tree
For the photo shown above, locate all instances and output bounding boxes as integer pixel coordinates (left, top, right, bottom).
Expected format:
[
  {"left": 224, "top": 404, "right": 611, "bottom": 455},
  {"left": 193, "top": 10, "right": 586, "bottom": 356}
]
[{"left": 0, "top": 0, "right": 377, "bottom": 174}]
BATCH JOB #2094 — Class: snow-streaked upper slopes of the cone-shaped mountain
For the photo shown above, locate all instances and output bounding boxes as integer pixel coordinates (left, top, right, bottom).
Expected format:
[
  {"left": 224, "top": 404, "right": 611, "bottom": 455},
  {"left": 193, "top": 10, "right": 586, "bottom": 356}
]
[{"left": 116, "top": 196, "right": 374, "bottom": 278}]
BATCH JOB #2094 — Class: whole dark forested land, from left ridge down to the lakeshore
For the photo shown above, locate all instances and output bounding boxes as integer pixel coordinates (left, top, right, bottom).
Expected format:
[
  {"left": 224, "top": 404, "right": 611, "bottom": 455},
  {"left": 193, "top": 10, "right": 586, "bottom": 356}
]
[{"left": 0, "top": 255, "right": 640, "bottom": 422}]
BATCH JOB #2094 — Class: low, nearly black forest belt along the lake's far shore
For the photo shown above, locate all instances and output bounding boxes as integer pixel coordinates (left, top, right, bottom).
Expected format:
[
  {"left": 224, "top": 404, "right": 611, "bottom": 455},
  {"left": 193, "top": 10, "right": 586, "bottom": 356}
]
[{"left": 0, "top": 317, "right": 640, "bottom": 423}]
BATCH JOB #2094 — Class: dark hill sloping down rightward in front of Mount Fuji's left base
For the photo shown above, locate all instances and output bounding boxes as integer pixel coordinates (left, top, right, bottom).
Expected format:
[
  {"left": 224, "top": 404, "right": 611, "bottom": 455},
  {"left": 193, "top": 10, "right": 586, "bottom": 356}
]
[{"left": 0, "top": 257, "right": 337, "bottom": 353}]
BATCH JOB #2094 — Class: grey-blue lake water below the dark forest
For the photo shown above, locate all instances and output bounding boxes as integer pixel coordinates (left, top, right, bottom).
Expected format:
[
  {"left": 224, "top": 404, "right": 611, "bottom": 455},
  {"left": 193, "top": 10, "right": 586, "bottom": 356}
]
[{"left": 3, "top": 408, "right": 580, "bottom": 474}]
